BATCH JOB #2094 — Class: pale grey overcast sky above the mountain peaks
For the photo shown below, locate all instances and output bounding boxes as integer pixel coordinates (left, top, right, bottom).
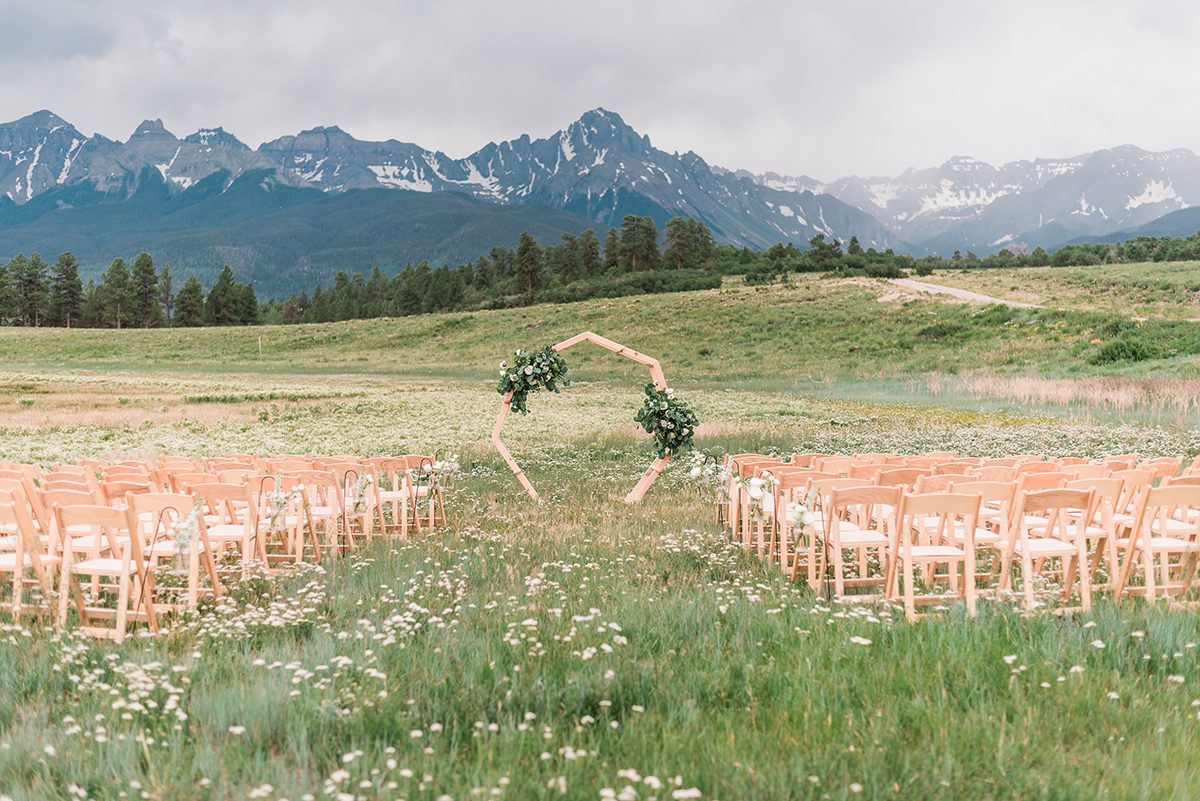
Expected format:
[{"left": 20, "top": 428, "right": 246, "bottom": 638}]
[{"left": 0, "top": 0, "right": 1200, "bottom": 180}]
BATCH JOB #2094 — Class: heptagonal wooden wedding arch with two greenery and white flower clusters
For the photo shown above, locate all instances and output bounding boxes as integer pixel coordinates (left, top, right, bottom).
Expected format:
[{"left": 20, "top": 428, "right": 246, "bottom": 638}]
[{"left": 492, "top": 331, "right": 700, "bottom": 504}]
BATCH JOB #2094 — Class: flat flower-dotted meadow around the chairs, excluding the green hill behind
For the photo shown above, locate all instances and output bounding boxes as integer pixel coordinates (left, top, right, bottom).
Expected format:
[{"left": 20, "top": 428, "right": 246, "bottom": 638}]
[{"left": 0, "top": 364, "right": 1200, "bottom": 801}]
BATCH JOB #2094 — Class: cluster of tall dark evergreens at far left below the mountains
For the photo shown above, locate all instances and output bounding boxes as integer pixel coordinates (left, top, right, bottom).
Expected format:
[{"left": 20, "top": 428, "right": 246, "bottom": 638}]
[{"left": 0, "top": 253, "right": 259, "bottom": 329}]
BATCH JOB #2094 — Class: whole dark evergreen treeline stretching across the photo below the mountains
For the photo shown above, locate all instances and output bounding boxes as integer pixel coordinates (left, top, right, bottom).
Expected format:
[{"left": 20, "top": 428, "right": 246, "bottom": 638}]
[{"left": 7, "top": 215, "right": 1200, "bottom": 329}]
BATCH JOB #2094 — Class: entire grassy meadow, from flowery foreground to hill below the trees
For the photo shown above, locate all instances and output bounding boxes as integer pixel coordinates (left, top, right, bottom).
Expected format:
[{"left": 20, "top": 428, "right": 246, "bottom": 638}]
[{"left": 0, "top": 266, "right": 1200, "bottom": 801}]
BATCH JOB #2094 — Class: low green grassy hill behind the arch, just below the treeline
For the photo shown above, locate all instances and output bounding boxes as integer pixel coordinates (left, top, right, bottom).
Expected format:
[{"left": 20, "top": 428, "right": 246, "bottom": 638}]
[{"left": 0, "top": 267, "right": 1200, "bottom": 386}]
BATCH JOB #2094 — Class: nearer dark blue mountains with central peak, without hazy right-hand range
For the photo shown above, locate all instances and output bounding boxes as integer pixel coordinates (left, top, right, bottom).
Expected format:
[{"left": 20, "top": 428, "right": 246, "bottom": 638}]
[{"left": 0, "top": 109, "right": 899, "bottom": 292}]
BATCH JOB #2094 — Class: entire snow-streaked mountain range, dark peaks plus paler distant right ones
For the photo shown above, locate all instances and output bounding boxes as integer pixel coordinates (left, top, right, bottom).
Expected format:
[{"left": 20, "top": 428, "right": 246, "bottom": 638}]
[{"left": 0, "top": 108, "right": 1200, "bottom": 289}]
